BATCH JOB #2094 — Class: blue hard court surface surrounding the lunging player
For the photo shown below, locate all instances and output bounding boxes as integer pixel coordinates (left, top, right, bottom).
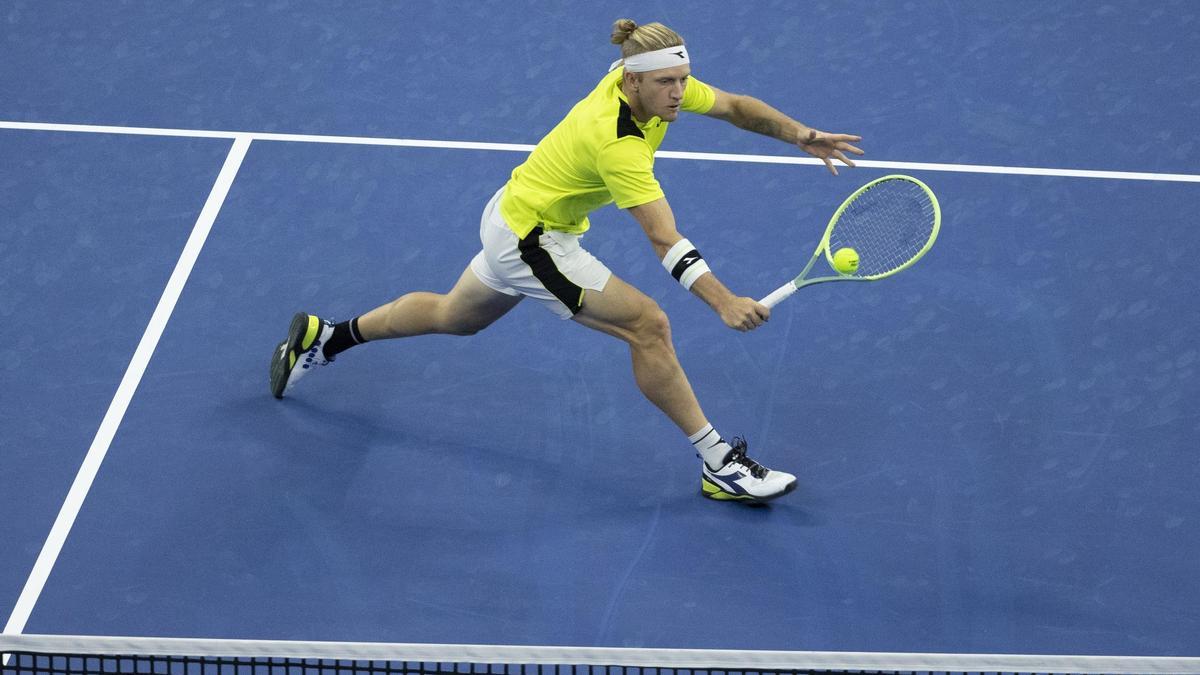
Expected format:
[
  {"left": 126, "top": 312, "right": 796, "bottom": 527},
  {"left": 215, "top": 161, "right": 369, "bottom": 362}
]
[{"left": 0, "top": 0, "right": 1200, "bottom": 656}]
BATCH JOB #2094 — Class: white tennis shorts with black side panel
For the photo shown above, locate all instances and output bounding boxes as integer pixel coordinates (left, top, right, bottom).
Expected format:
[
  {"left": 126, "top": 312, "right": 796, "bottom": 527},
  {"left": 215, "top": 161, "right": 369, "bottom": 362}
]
[{"left": 470, "top": 187, "right": 612, "bottom": 318}]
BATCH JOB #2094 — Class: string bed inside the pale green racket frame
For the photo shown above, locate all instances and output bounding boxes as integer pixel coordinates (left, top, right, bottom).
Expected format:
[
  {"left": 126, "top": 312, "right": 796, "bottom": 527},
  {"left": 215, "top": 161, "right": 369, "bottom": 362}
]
[{"left": 829, "top": 177, "right": 937, "bottom": 279}]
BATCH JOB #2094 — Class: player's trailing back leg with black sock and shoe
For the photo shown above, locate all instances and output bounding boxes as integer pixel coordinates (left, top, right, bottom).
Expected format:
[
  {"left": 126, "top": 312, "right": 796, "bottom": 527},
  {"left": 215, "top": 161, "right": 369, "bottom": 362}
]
[{"left": 270, "top": 268, "right": 521, "bottom": 399}]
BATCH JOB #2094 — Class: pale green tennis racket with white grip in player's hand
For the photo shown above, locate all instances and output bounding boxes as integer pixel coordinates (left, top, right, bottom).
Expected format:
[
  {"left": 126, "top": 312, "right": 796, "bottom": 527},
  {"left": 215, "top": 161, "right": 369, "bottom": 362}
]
[{"left": 758, "top": 175, "right": 942, "bottom": 307}]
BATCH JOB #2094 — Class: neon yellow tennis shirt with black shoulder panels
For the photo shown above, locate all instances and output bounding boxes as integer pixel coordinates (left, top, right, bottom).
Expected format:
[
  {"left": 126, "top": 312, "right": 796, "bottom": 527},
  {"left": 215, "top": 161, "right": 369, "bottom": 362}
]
[{"left": 500, "top": 68, "right": 716, "bottom": 238}]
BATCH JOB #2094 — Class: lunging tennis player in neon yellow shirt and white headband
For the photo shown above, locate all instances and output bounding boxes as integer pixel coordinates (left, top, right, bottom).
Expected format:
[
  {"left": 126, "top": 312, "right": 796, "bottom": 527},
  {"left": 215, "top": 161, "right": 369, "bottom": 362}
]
[{"left": 271, "top": 19, "right": 863, "bottom": 502}]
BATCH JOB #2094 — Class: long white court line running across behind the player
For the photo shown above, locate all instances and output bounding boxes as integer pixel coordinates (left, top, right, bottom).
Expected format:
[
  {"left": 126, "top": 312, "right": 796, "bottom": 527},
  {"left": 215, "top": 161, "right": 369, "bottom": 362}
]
[{"left": 0, "top": 121, "right": 1200, "bottom": 183}]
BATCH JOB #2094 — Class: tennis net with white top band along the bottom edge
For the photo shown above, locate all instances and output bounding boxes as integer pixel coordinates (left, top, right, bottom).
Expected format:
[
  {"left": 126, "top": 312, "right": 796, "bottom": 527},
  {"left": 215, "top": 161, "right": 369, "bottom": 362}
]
[{"left": 0, "top": 634, "right": 1200, "bottom": 675}]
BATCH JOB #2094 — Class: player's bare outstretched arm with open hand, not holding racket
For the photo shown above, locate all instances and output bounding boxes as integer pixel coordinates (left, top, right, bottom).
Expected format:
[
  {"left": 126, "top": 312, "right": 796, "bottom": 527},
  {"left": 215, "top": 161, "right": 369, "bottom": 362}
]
[{"left": 704, "top": 86, "right": 863, "bottom": 175}]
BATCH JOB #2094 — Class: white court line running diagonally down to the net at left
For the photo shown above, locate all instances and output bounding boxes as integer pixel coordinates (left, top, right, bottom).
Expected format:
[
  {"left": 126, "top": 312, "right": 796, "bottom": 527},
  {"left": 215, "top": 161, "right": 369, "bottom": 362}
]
[{"left": 4, "top": 136, "right": 251, "bottom": 634}]
